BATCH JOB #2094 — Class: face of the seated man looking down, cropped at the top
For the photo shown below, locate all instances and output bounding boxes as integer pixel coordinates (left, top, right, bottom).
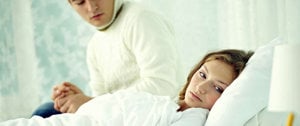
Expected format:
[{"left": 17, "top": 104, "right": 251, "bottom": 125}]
[{"left": 69, "top": 0, "right": 114, "bottom": 27}]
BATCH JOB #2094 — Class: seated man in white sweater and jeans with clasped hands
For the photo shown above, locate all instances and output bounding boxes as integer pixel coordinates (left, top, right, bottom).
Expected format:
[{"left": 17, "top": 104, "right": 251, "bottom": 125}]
[{"left": 33, "top": 0, "right": 184, "bottom": 117}]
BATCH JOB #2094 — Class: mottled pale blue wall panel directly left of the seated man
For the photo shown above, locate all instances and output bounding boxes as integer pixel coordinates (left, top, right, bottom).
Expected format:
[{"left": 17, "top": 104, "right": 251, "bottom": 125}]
[{"left": 32, "top": 0, "right": 93, "bottom": 100}]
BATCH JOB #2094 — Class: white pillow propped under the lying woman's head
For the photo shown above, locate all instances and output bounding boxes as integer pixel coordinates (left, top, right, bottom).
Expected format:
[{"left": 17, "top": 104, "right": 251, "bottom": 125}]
[{"left": 205, "top": 39, "right": 281, "bottom": 126}]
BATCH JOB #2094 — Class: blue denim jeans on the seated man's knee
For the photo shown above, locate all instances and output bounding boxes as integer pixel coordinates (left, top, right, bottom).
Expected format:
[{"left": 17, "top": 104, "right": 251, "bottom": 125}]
[{"left": 32, "top": 102, "right": 61, "bottom": 118}]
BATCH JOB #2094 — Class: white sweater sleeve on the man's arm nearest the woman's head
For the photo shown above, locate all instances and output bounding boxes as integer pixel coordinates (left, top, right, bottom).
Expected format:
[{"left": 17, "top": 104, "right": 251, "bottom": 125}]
[{"left": 124, "top": 11, "right": 183, "bottom": 96}]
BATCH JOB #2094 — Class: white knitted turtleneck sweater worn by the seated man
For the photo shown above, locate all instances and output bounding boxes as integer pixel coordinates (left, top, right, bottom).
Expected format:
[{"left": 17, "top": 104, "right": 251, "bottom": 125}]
[{"left": 87, "top": 2, "right": 185, "bottom": 97}]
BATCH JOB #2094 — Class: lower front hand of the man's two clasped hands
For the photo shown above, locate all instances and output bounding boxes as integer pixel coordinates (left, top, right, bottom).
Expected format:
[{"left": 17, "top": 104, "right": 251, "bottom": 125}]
[{"left": 54, "top": 93, "right": 92, "bottom": 113}]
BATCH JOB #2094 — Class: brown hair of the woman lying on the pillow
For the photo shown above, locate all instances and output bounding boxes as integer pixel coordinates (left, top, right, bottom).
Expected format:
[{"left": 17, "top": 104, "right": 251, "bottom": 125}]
[{"left": 179, "top": 49, "right": 254, "bottom": 100}]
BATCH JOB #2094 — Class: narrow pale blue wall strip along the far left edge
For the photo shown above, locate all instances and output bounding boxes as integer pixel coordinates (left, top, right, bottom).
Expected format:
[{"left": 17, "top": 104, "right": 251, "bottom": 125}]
[{"left": 0, "top": 1, "right": 18, "bottom": 96}]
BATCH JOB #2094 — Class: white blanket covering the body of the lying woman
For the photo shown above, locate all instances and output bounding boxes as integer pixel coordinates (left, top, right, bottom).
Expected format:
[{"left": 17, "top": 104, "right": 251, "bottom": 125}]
[{"left": 0, "top": 91, "right": 208, "bottom": 126}]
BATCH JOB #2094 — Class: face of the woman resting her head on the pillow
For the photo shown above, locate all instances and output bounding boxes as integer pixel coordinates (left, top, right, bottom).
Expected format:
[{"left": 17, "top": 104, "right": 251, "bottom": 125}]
[{"left": 184, "top": 60, "right": 235, "bottom": 109}]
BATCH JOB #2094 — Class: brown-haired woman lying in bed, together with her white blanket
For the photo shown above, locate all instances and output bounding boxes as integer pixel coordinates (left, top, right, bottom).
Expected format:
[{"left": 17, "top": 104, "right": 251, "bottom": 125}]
[{"left": 0, "top": 50, "right": 253, "bottom": 126}]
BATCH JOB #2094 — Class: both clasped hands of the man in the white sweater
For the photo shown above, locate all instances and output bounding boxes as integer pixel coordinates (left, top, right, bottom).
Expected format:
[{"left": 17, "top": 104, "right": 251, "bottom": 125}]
[{"left": 51, "top": 82, "right": 92, "bottom": 113}]
